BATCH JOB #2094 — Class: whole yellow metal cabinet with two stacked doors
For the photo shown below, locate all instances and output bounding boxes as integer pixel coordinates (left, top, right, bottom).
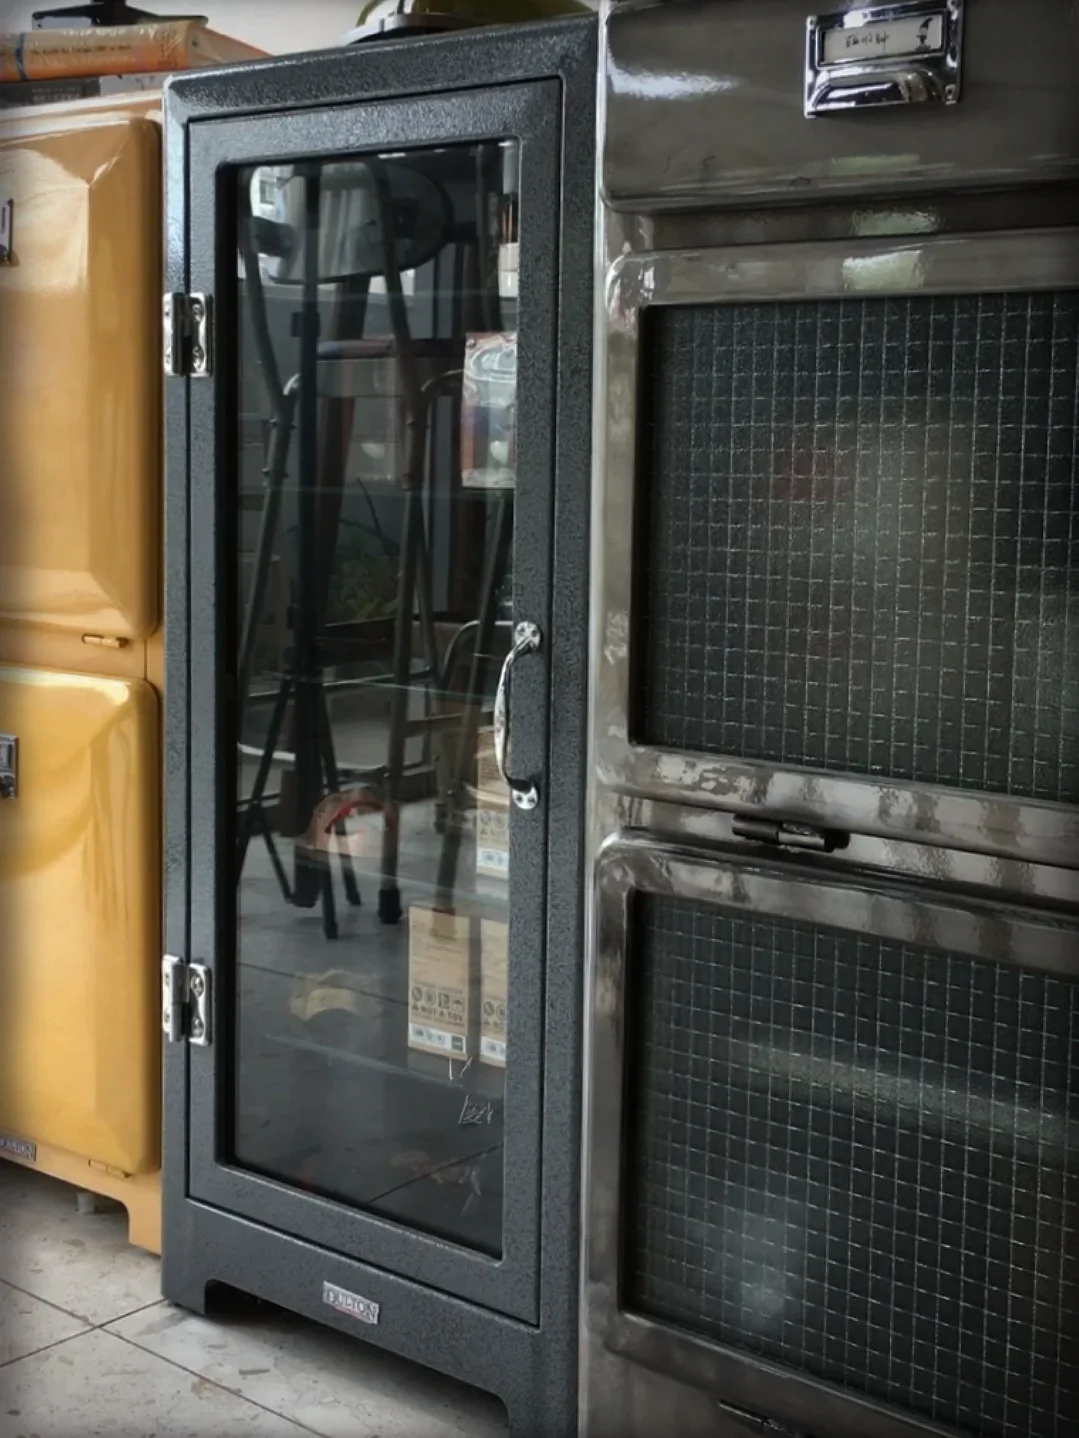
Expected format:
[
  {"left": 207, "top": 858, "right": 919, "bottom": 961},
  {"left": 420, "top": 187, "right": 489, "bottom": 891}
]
[{"left": 0, "top": 95, "right": 163, "bottom": 1250}]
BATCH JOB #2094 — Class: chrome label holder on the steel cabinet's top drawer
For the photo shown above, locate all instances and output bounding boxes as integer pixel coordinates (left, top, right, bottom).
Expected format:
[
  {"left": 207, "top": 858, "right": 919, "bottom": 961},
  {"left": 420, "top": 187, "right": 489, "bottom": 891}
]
[{"left": 806, "top": 0, "right": 964, "bottom": 119}]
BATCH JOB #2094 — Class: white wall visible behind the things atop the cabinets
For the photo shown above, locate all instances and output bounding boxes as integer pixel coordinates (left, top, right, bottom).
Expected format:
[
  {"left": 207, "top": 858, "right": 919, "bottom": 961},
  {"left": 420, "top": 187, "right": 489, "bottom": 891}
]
[{"left": 0, "top": 0, "right": 598, "bottom": 55}]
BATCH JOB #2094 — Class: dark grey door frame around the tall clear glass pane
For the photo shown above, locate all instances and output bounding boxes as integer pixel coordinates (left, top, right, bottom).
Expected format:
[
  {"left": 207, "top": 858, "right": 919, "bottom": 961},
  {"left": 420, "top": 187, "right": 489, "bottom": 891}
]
[{"left": 178, "top": 79, "right": 561, "bottom": 1323}]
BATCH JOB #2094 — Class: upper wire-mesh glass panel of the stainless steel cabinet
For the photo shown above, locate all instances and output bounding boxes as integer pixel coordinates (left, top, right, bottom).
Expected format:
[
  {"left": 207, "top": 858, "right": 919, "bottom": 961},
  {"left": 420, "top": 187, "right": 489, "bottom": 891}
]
[{"left": 633, "top": 293, "right": 1079, "bottom": 802}]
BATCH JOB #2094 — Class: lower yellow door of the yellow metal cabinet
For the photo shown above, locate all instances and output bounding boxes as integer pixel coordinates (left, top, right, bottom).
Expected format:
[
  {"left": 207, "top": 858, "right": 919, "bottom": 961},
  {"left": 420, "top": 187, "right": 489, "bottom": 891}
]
[{"left": 0, "top": 666, "right": 160, "bottom": 1173}]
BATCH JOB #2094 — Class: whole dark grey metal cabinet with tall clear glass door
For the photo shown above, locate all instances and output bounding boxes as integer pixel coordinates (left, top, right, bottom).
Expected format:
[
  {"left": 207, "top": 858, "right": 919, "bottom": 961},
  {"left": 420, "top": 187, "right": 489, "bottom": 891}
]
[{"left": 164, "top": 20, "right": 596, "bottom": 1435}]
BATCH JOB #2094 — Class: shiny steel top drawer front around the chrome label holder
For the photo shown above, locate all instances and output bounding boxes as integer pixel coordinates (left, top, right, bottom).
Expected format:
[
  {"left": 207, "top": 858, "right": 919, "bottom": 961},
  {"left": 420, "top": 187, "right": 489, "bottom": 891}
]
[{"left": 601, "top": 0, "right": 1079, "bottom": 211}]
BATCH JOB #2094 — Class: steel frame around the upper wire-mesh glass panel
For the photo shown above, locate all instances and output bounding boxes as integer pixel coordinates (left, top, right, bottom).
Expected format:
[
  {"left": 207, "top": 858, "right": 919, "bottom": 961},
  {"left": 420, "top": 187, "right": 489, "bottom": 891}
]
[{"left": 593, "top": 227, "right": 1079, "bottom": 869}]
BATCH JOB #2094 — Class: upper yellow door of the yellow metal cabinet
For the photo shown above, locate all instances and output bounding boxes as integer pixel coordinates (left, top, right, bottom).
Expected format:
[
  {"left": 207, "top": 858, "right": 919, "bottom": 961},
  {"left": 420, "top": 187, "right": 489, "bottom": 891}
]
[{"left": 0, "top": 109, "right": 161, "bottom": 638}]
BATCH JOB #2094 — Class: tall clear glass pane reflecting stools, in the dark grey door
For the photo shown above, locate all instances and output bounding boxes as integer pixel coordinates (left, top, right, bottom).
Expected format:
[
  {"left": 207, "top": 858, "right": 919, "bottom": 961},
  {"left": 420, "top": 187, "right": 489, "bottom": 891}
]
[{"left": 230, "top": 144, "right": 518, "bottom": 1254}]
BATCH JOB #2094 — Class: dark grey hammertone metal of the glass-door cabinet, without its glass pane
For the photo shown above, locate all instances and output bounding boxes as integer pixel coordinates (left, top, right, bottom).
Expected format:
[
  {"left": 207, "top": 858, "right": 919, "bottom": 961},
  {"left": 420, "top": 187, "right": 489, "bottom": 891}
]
[{"left": 163, "top": 19, "right": 596, "bottom": 1438}]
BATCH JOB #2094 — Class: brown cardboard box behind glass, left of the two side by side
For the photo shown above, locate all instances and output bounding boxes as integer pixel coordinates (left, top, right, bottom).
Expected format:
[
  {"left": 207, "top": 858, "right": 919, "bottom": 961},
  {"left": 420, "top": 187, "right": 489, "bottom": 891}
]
[{"left": 409, "top": 906, "right": 473, "bottom": 1058}]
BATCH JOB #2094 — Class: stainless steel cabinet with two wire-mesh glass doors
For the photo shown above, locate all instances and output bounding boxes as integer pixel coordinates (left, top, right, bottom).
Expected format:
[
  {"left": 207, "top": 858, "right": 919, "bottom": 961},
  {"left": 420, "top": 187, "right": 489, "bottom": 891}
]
[{"left": 581, "top": 0, "right": 1079, "bottom": 1438}]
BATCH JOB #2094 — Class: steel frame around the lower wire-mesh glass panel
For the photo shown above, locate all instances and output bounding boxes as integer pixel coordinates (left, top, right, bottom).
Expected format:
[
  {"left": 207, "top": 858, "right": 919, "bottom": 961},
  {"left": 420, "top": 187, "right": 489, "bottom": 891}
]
[{"left": 581, "top": 833, "right": 1079, "bottom": 1438}]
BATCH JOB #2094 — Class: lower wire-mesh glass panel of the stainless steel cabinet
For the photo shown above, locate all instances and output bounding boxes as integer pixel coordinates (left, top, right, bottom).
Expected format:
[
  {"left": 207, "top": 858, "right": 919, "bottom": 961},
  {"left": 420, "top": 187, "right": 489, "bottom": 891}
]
[{"left": 623, "top": 899, "right": 1079, "bottom": 1438}]
